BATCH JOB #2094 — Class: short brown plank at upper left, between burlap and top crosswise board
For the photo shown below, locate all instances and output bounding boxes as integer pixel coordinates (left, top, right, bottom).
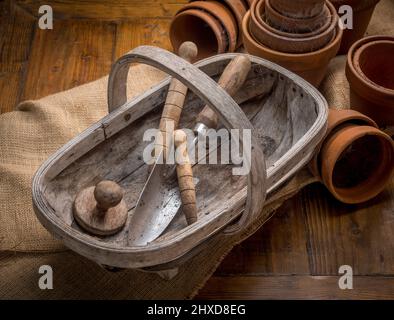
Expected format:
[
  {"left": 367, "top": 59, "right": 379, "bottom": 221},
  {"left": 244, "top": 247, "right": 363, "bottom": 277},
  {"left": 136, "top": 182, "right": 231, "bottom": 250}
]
[{"left": 22, "top": 20, "right": 116, "bottom": 100}]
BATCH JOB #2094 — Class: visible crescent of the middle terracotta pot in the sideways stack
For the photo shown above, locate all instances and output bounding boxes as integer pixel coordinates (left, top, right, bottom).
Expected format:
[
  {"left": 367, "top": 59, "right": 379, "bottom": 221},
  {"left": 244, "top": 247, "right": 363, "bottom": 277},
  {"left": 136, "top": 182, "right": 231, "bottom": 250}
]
[{"left": 178, "top": 1, "right": 238, "bottom": 52}]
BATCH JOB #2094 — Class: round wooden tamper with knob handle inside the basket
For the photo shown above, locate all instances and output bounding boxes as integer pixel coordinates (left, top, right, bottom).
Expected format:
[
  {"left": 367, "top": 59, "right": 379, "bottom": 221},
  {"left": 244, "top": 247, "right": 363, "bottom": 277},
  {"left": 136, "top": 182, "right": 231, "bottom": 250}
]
[{"left": 73, "top": 181, "right": 127, "bottom": 236}]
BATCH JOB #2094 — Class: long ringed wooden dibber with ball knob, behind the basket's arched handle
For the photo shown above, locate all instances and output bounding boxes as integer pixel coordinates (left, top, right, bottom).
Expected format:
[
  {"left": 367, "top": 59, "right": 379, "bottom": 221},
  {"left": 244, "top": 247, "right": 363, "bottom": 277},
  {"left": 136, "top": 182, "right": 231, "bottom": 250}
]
[{"left": 155, "top": 41, "right": 198, "bottom": 159}]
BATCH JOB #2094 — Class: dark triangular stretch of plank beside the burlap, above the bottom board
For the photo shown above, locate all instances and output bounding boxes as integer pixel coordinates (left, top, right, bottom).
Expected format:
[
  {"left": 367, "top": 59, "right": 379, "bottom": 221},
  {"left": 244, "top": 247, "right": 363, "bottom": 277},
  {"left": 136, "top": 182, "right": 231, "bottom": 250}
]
[{"left": 215, "top": 197, "right": 310, "bottom": 276}]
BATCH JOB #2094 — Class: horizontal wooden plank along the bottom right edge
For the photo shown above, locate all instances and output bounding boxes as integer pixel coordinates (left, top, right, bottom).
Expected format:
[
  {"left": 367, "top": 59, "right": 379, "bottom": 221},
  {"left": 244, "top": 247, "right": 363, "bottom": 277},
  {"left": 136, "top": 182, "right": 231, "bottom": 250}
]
[{"left": 196, "top": 275, "right": 394, "bottom": 299}]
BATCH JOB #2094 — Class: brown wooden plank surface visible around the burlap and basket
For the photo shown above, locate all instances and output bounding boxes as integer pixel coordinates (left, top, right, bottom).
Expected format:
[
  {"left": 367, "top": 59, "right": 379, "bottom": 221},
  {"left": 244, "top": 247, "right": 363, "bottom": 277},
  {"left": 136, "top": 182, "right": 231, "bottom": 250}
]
[{"left": 0, "top": 0, "right": 394, "bottom": 299}]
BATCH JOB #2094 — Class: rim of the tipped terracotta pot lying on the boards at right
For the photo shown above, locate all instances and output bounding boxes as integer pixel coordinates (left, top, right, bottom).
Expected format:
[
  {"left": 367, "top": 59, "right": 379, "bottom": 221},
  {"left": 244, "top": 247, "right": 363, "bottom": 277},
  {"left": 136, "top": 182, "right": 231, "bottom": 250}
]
[{"left": 321, "top": 124, "right": 394, "bottom": 203}]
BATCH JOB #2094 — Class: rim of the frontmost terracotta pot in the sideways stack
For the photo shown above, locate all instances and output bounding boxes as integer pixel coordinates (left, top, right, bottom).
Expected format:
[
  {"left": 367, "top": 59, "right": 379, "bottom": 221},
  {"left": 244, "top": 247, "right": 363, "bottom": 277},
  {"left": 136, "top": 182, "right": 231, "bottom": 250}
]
[{"left": 170, "top": 9, "right": 228, "bottom": 57}]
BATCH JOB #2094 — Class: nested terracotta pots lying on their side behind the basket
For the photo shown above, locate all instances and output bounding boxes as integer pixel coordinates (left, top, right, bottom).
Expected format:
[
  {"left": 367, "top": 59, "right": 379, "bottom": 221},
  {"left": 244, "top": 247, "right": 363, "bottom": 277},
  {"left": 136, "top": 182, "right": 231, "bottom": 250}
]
[{"left": 170, "top": 0, "right": 252, "bottom": 59}]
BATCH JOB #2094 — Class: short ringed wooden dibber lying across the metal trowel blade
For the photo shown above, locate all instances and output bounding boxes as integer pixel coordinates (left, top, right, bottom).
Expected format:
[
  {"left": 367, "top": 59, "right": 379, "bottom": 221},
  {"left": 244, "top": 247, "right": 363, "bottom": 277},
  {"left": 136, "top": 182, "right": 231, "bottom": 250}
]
[{"left": 174, "top": 130, "right": 197, "bottom": 225}]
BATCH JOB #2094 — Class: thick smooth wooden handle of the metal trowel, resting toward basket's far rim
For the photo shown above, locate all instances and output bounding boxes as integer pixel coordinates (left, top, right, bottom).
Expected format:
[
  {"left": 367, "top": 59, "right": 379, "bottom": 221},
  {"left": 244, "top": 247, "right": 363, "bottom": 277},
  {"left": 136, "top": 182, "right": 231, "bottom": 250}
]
[{"left": 197, "top": 55, "right": 251, "bottom": 129}]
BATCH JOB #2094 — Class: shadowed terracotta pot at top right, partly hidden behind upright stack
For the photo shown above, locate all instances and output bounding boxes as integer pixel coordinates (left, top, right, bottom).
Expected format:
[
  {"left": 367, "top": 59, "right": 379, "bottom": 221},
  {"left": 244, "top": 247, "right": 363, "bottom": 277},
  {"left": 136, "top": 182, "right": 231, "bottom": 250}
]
[{"left": 331, "top": 0, "right": 380, "bottom": 54}]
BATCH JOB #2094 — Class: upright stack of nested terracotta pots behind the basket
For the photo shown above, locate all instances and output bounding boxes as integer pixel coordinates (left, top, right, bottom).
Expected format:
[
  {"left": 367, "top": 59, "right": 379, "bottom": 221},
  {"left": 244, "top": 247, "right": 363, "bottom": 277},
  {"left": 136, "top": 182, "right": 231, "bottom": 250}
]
[{"left": 242, "top": 0, "right": 343, "bottom": 86}]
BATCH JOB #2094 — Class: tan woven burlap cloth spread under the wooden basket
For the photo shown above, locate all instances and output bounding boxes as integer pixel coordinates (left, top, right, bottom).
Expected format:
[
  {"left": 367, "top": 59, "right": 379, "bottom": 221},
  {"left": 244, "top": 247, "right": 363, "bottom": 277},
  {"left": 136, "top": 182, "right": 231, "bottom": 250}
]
[{"left": 0, "top": 0, "right": 394, "bottom": 299}]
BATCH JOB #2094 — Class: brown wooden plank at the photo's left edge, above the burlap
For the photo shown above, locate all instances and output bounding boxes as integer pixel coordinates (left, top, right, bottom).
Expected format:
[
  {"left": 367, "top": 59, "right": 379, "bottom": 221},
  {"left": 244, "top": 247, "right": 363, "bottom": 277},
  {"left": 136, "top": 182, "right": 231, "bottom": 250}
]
[{"left": 0, "top": 1, "right": 34, "bottom": 114}]
